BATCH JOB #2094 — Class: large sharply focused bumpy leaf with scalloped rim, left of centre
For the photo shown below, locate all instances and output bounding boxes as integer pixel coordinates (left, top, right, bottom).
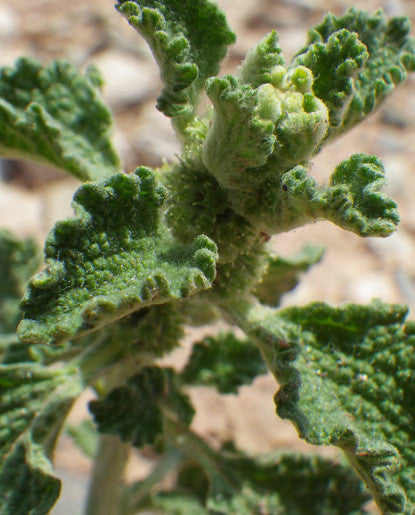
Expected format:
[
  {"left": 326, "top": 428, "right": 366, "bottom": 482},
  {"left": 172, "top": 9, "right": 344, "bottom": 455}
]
[{"left": 18, "top": 167, "right": 217, "bottom": 344}]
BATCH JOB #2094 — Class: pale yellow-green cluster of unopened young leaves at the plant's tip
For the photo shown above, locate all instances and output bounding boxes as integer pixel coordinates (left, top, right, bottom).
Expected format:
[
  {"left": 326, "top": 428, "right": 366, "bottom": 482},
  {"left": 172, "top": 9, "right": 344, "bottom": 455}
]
[{"left": 203, "top": 65, "right": 328, "bottom": 192}]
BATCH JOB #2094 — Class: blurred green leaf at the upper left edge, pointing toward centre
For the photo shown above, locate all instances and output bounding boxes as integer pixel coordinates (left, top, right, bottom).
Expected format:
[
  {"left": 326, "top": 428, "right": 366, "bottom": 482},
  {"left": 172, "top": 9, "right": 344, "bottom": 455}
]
[{"left": 0, "top": 58, "right": 120, "bottom": 180}]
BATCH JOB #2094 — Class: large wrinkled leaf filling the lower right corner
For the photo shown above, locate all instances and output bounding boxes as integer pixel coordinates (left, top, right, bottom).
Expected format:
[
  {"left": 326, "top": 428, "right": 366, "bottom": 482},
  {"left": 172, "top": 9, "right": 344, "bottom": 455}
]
[{"left": 240, "top": 301, "right": 415, "bottom": 514}]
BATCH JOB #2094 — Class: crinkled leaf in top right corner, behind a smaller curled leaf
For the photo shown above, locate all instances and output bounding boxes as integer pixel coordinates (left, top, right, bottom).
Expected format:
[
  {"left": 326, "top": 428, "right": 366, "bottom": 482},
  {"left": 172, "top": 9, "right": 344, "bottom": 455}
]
[{"left": 295, "top": 8, "right": 415, "bottom": 136}]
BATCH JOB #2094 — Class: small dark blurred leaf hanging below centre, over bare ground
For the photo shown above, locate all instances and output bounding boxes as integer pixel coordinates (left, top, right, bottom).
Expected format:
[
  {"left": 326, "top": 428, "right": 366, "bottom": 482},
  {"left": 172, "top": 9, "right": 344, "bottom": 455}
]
[{"left": 181, "top": 332, "right": 267, "bottom": 394}]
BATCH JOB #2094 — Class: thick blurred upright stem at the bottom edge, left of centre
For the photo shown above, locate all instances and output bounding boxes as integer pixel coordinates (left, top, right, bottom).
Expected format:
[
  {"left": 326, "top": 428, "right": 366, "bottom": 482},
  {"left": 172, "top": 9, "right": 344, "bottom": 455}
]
[{"left": 85, "top": 435, "right": 129, "bottom": 515}]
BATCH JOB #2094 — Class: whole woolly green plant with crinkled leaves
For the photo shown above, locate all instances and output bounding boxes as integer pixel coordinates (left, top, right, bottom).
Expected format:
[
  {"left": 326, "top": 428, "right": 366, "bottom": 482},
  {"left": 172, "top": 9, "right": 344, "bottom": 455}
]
[{"left": 0, "top": 0, "right": 415, "bottom": 514}]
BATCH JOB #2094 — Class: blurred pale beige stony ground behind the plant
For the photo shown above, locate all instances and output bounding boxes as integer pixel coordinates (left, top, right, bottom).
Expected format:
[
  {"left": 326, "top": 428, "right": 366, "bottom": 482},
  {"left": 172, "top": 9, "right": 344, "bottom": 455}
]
[{"left": 0, "top": 0, "right": 415, "bottom": 515}]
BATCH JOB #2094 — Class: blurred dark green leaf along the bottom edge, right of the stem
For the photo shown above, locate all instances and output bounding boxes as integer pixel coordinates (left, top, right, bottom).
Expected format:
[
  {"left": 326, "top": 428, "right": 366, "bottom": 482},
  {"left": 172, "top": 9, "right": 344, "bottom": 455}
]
[{"left": 147, "top": 444, "right": 370, "bottom": 515}]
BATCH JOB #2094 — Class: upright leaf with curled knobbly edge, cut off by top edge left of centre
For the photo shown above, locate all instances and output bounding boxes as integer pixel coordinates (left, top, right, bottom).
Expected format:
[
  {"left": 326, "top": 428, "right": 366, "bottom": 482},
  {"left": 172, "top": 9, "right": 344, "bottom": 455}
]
[{"left": 117, "top": 0, "right": 235, "bottom": 125}]
